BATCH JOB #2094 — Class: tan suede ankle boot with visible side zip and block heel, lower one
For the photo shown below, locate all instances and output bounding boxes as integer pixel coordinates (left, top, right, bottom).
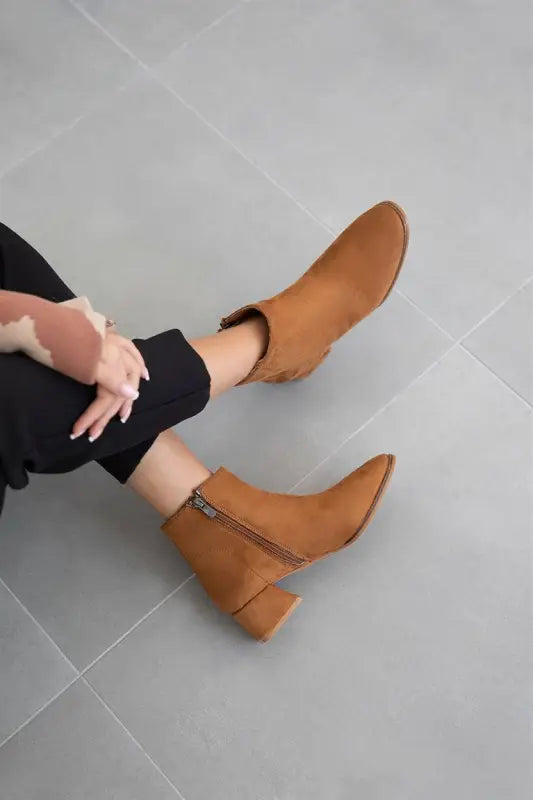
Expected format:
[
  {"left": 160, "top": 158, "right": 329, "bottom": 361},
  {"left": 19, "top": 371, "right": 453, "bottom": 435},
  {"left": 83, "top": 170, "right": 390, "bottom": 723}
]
[{"left": 163, "top": 455, "right": 395, "bottom": 642}]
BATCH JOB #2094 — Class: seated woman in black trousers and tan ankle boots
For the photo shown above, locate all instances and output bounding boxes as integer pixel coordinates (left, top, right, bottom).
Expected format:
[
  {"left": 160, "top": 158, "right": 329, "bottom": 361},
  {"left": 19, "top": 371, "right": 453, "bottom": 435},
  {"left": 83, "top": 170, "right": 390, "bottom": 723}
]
[{"left": 0, "top": 201, "right": 408, "bottom": 641}]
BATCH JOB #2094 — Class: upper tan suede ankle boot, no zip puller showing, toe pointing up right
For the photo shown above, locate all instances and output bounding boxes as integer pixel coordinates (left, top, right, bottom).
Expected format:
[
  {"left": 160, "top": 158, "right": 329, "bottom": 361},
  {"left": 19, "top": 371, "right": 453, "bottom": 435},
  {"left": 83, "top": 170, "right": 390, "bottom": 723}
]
[{"left": 221, "top": 200, "right": 409, "bottom": 383}]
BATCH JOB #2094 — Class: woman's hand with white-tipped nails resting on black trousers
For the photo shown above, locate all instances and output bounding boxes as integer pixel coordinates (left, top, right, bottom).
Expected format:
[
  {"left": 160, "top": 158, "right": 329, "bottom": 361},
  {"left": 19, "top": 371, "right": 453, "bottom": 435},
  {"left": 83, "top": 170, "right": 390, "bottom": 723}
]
[{"left": 70, "top": 331, "right": 150, "bottom": 442}]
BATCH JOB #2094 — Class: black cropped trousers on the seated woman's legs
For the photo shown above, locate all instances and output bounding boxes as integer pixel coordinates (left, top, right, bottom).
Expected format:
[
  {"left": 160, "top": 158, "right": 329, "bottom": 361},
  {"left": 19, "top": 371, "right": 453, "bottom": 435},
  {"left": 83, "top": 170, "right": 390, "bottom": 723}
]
[{"left": 0, "top": 223, "right": 210, "bottom": 512}]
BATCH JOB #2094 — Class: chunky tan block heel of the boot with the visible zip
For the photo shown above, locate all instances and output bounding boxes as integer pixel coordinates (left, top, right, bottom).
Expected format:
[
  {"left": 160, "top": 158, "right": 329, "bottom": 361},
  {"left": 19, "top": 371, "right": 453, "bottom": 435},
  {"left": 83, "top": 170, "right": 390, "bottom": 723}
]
[{"left": 233, "top": 585, "right": 302, "bottom": 642}]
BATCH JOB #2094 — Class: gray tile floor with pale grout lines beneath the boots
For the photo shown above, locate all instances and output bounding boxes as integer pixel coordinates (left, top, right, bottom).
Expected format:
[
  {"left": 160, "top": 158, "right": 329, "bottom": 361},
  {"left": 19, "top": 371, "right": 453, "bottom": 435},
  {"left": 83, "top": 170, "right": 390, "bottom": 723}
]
[{"left": 0, "top": 0, "right": 533, "bottom": 800}]
